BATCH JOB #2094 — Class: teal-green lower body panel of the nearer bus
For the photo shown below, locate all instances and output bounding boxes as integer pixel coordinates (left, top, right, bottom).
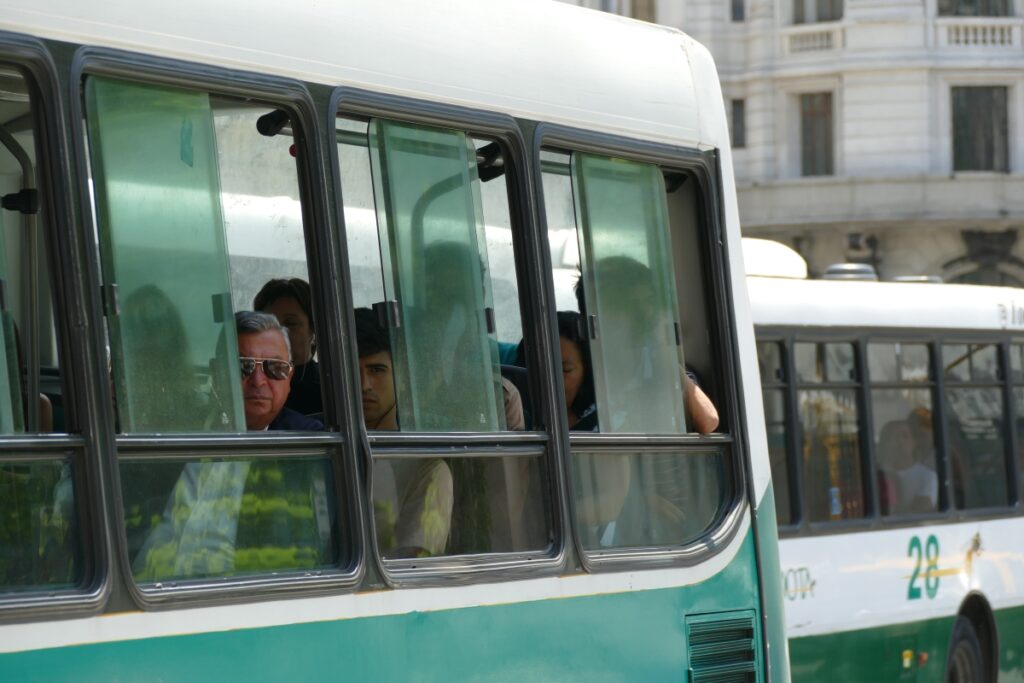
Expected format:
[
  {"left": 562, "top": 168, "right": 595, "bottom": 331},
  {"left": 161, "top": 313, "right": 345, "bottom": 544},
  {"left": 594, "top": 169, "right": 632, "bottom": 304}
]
[{"left": 0, "top": 535, "right": 763, "bottom": 683}]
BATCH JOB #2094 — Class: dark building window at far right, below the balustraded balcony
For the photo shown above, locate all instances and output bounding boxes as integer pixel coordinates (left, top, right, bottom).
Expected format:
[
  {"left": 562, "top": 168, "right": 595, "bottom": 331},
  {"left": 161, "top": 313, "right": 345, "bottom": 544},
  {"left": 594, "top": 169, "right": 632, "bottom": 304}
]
[{"left": 952, "top": 86, "right": 1010, "bottom": 173}]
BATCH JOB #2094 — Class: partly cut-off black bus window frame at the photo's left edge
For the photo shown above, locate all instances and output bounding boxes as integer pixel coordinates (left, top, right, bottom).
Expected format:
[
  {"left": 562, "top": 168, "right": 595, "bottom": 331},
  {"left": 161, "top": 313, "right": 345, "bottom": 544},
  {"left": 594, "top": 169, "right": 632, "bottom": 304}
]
[{"left": 0, "top": 32, "right": 112, "bottom": 623}]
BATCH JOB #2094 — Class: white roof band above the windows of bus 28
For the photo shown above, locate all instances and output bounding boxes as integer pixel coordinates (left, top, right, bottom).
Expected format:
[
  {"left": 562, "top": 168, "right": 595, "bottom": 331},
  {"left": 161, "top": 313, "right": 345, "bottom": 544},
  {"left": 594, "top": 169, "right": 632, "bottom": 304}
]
[{"left": 746, "top": 276, "right": 1024, "bottom": 333}]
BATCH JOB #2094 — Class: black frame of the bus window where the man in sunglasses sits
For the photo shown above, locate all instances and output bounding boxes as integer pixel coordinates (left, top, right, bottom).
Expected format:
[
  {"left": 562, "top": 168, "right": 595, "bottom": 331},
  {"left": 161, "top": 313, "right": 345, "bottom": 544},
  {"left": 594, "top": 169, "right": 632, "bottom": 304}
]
[{"left": 70, "top": 46, "right": 366, "bottom": 609}]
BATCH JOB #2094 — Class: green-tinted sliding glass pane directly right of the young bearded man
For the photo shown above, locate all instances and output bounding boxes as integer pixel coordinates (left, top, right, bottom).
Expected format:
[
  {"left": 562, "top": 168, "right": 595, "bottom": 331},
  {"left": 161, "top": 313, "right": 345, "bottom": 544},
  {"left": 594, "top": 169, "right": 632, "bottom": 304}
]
[{"left": 369, "top": 120, "right": 506, "bottom": 431}]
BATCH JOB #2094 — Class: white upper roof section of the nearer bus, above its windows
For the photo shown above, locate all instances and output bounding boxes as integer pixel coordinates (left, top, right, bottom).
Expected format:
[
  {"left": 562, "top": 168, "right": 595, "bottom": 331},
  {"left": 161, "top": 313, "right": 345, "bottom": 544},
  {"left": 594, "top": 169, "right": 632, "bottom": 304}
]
[{"left": 0, "top": 0, "right": 728, "bottom": 147}]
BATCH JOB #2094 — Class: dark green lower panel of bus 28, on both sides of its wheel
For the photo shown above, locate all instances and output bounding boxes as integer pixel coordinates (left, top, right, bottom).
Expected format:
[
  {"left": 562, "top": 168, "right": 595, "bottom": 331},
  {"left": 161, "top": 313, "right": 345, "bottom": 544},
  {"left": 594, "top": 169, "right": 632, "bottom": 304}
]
[{"left": 790, "top": 607, "right": 1024, "bottom": 683}]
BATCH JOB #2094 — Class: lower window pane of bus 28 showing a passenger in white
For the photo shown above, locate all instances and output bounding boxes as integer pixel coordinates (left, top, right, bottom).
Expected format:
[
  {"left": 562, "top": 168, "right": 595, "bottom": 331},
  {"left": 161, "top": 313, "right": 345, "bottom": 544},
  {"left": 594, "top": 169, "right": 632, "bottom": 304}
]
[{"left": 871, "top": 389, "right": 940, "bottom": 515}]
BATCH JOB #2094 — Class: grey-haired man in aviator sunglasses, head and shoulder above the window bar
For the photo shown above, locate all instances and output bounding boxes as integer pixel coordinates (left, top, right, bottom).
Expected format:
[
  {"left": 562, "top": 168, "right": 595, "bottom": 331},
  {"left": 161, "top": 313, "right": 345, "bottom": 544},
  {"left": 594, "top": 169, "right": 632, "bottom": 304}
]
[{"left": 234, "top": 310, "right": 324, "bottom": 431}]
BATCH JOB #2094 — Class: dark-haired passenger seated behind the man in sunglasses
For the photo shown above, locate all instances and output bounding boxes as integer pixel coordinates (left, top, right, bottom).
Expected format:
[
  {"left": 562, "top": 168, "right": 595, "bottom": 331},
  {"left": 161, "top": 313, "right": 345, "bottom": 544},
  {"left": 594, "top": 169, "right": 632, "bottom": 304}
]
[{"left": 253, "top": 278, "right": 324, "bottom": 415}]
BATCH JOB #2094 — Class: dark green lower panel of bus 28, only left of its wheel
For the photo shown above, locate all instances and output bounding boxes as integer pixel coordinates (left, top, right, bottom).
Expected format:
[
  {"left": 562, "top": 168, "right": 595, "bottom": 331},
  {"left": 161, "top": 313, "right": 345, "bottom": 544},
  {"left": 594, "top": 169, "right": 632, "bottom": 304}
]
[{"left": 790, "top": 617, "right": 953, "bottom": 683}]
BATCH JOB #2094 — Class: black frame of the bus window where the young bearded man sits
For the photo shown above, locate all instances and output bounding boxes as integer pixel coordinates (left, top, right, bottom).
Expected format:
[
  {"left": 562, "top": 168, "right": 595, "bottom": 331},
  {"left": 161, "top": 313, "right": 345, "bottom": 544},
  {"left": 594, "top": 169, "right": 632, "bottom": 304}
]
[{"left": 326, "top": 86, "right": 573, "bottom": 588}]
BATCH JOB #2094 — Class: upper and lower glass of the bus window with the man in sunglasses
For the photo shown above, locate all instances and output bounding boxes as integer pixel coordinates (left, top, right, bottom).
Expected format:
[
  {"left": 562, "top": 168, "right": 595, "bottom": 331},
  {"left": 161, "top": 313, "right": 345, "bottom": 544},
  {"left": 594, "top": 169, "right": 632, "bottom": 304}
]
[{"left": 85, "top": 76, "right": 340, "bottom": 582}]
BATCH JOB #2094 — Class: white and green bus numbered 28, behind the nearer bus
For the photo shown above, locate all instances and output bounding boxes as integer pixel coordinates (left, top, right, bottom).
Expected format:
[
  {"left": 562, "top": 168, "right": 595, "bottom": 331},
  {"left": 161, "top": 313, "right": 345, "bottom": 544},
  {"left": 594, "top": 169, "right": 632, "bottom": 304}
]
[{"left": 744, "top": 239, "right": 1024, "bottom": 682}]
